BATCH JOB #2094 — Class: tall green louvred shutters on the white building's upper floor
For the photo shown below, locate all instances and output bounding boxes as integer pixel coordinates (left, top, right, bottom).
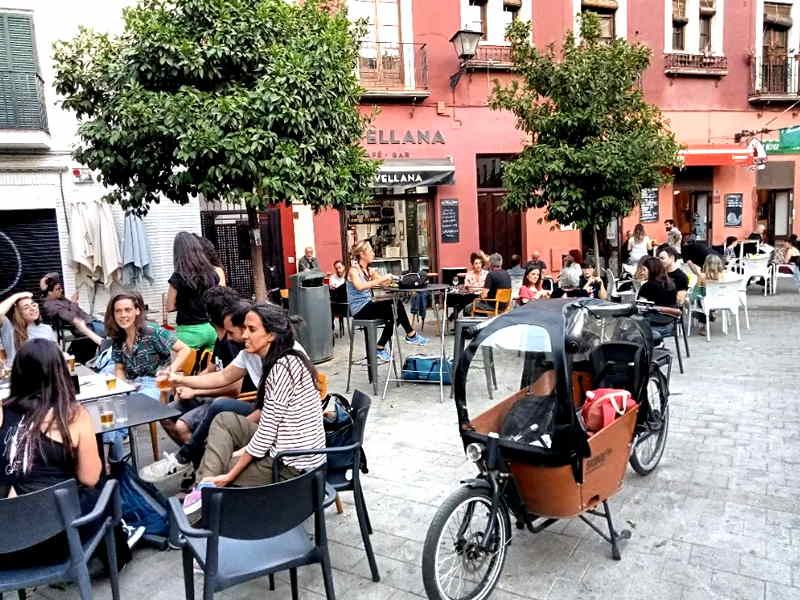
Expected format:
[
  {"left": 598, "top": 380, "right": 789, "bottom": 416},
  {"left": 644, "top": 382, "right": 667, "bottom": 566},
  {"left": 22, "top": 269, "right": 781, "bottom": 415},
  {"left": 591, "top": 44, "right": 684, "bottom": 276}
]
[{"left": 0, "top": 12, "right": 47, "bottom": 131}]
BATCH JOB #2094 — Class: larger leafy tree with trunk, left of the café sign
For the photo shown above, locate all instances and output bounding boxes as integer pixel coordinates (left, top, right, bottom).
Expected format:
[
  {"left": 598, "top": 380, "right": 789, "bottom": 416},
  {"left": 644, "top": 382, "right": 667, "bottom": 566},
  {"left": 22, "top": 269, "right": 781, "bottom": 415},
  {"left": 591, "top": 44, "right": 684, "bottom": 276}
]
[{"left": 55, "top": 0, "right": 377, "bottom": 299}]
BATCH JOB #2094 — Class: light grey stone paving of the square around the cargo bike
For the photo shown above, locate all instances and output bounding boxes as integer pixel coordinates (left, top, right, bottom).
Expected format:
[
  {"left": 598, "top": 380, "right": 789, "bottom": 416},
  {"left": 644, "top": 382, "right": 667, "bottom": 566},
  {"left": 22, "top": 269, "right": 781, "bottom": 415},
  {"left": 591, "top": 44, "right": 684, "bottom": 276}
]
[{"left": 31, "top": 281, "right": 800, "bottom": 600}]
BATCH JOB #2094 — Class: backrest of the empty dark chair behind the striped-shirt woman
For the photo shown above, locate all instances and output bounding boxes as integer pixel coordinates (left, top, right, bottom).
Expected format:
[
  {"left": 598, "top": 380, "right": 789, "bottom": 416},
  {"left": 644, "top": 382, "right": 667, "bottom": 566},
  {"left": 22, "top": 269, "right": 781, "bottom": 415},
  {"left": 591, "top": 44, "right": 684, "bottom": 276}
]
[{"left": 201, "top": 465, "right": 325, "bottom": 540}]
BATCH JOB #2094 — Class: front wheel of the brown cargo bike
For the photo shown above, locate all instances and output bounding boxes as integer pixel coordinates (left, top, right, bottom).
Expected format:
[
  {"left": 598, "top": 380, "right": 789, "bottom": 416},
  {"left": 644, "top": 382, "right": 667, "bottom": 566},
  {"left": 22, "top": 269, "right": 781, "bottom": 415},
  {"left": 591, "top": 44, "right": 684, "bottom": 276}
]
[{"left": 422, "top": 487, "right": 510, "bottom": 600}]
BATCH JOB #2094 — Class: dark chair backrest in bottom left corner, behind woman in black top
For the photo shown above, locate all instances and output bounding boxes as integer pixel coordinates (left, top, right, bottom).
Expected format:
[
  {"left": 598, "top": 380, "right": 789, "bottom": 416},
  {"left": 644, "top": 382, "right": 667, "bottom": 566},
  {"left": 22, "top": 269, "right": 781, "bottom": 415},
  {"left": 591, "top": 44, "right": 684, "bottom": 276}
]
[{"left": 0, "top": 479, "right": 80, "bottom": 553}]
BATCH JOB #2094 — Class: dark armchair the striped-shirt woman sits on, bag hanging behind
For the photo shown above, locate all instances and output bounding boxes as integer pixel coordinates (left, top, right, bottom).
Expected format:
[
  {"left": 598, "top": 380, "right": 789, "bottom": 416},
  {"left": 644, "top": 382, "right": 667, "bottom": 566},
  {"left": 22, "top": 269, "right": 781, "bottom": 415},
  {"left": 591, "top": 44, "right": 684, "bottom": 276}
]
[{"left": 272, "top": 390, "right": 381, "bottom": 581}]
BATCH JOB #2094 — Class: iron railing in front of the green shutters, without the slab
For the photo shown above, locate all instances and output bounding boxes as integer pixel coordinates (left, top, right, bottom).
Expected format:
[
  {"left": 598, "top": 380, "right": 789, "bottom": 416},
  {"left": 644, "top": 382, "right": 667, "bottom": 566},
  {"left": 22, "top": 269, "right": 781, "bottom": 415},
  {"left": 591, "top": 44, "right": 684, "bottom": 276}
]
[{"left": 0, "top": 69, "right": 48, "bottom": 131}]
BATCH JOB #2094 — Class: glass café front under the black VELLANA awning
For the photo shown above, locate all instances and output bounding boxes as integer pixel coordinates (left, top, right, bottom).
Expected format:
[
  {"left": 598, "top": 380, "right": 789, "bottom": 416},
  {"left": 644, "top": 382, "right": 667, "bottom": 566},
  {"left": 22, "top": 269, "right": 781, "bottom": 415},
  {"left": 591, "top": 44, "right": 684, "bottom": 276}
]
[{"left": 345, "top": 195, "right": 435, "bottom": 274}]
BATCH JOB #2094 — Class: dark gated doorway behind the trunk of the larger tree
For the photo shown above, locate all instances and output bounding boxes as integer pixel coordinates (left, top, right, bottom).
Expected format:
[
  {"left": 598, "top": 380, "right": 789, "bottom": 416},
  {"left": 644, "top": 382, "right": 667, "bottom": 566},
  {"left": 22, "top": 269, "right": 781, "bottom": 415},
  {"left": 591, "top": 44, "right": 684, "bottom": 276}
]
[{"left": 200, "top": 208, "right": 286, "bottom": 298}]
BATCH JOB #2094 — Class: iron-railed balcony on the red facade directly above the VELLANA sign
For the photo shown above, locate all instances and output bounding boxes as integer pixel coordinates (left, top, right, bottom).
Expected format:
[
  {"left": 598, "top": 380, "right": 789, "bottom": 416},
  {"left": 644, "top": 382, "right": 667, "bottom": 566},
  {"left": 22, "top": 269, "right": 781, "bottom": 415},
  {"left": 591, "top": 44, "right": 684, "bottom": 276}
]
[{"left": 358, "top": 42, "right": 430, "bottom": 101}]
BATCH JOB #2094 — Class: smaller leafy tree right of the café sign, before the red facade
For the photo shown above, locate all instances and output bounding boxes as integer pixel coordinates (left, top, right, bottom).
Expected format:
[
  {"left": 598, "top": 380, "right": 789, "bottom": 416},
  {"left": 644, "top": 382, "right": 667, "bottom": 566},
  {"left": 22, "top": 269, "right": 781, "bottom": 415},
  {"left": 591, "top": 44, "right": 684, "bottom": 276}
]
[{"left": 490, "top": 13, "right": 679, "bottom": 268}]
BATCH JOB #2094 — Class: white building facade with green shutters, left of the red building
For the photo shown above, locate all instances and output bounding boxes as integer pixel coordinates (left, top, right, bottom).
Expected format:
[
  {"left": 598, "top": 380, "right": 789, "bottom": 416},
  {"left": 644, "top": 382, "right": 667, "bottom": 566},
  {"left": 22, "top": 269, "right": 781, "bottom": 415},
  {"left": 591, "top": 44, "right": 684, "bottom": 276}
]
[{"left": 0, "top": 0, "right": 200, "bottom": 318}]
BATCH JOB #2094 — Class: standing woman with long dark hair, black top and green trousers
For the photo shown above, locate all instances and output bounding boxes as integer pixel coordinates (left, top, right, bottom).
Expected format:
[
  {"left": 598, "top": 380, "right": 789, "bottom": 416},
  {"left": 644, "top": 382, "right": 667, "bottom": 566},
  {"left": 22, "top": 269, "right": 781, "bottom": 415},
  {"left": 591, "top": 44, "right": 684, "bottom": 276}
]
[{"left": 165, "top": 231, "right": 220, "bottom": 350}]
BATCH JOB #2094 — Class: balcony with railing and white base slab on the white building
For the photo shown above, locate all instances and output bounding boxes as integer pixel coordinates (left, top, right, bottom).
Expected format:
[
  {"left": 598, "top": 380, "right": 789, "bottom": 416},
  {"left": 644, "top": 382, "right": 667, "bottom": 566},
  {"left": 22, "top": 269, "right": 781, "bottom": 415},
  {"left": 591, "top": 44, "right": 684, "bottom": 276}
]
[{"left": 0, "top": 69, "right": 50, "bottom": 149}]
